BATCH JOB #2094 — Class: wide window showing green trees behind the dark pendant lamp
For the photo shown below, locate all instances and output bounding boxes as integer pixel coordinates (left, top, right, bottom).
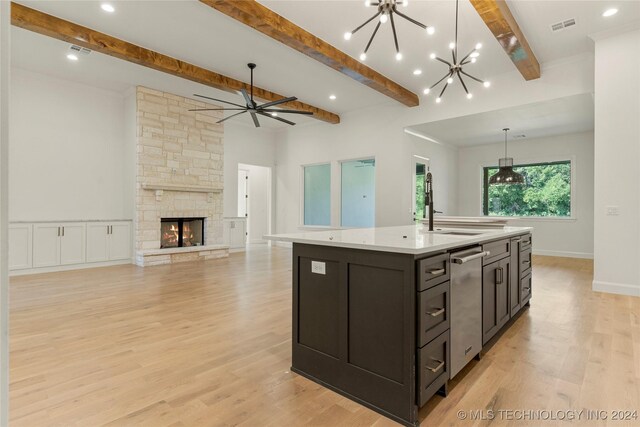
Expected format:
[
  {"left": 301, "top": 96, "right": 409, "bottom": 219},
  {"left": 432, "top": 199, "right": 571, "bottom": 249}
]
[{"left": 483, "top": 161, "right": 571, "bottom": 217}]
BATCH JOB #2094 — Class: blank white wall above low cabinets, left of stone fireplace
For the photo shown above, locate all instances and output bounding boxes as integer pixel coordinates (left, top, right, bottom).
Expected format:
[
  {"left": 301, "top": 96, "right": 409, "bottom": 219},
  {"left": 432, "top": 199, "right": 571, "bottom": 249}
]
[{"left": 9, "top": 69, "right": 133, "bottom": 221}]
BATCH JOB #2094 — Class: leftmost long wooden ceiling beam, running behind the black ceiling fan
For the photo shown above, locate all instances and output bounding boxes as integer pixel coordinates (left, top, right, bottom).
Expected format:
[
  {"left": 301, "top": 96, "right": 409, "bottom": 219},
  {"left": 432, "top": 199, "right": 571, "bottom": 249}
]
[{"left": 11, "top": 3, "right": 340, "bottom": 124}]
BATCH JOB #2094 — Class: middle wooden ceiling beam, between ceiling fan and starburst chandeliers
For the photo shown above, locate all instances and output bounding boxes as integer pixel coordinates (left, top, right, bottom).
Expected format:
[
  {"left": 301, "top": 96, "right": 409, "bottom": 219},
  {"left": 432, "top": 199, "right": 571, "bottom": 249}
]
[{"left": 200, "top": 0, "right": 420, "bottom": 107}]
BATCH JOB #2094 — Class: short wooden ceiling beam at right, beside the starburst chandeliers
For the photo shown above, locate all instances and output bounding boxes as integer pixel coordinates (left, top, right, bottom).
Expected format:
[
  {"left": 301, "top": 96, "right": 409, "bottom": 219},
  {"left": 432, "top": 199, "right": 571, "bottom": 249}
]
[{"left": 470, "top": 0, "right": 540, "bottom": 80}]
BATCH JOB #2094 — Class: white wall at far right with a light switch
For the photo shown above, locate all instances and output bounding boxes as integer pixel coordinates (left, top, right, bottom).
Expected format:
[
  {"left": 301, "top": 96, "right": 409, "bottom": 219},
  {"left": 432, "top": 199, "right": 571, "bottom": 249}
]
[{"left": 593, "top": 30, "right": 640, "bottom": 296}]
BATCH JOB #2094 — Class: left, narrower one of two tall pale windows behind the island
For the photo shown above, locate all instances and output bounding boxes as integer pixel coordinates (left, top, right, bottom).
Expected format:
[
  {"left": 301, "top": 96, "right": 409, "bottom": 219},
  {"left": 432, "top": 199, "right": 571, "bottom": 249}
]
[{"left": 303, "top": 163, "right": 331, "bottom": 226}]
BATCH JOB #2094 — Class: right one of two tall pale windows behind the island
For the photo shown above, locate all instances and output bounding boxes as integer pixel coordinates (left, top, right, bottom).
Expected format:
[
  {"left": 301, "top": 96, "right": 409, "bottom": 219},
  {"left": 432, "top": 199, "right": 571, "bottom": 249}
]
[{"left": 340, "top": 159, "right": 376, "bottom": 227}]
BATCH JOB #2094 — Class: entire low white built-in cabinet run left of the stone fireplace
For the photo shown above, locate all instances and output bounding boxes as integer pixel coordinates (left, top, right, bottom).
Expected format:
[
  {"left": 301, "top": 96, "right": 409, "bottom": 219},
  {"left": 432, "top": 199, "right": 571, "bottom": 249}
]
[{"left": 9, "top": 221, "right": 132, "bottom": 273}]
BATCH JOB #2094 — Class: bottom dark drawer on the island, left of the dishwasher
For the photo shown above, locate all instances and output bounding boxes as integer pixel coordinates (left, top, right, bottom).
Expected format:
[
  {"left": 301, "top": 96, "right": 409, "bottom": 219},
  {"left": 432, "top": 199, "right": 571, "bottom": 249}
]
[{"left": 418, "top": 331, "right": 449, "bottom": 406}]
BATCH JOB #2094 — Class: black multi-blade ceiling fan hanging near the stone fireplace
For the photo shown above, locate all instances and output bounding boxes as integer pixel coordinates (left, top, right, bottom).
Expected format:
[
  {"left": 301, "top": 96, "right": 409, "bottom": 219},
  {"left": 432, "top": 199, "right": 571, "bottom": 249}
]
[{"left": 189, "top": 63, "right": 313, "bottom": 128}]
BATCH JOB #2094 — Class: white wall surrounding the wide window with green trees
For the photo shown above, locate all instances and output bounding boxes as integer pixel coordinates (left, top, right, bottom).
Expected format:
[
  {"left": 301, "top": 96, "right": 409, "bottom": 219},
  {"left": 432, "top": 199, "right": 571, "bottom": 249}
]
[{"left": 458, "top": 132, "right": 594, "bottom": 258}]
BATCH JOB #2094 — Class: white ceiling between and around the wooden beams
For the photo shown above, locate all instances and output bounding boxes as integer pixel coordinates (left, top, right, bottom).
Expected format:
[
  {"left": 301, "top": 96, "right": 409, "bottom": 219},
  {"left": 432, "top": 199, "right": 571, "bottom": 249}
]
[{"left": 12, "top": 0, "right": 640, "bottom": 123}]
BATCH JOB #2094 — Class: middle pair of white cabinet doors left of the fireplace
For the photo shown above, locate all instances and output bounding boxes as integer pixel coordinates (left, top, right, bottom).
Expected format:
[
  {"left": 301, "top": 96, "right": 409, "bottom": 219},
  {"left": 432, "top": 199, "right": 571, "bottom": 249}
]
[{"left": 33, "top": 222, "right": 86, "bottom": 268}]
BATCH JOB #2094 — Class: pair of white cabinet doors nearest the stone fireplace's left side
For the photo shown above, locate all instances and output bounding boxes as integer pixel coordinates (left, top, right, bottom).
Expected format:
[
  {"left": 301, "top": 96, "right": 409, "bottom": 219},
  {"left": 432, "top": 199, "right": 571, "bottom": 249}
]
[{"left": 87, "top": 221, "right": 131, "bottom": 262}]
